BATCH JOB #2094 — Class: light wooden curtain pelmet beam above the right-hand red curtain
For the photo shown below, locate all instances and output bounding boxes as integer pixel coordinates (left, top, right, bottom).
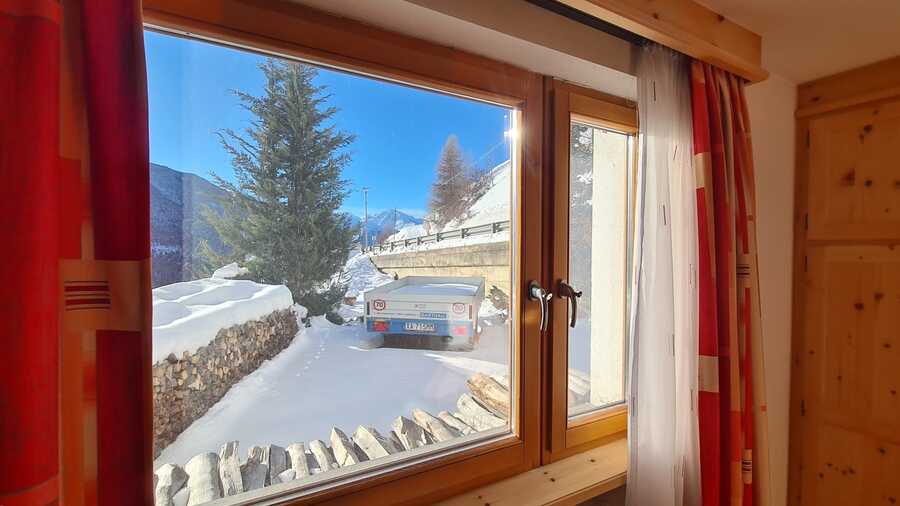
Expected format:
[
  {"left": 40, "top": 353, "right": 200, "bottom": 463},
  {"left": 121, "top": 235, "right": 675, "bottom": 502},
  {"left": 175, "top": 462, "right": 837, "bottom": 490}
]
[{"left": 558, "top": 0, "right": 769, "bottom": 82}]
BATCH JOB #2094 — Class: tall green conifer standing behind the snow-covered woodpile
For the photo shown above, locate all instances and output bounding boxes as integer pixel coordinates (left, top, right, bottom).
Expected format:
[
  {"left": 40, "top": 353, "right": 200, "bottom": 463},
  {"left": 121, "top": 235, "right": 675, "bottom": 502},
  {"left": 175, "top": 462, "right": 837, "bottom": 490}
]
[{"left": 205, "top": 59, "right": 356, "bottom": 314}]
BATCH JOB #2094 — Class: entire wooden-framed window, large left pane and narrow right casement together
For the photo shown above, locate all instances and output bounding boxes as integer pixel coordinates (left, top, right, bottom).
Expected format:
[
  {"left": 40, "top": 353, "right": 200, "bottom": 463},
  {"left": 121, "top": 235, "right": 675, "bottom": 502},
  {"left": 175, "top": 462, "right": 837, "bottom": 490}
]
[{"left": 143, "top": 0, "right": 636, "bottom": 504}]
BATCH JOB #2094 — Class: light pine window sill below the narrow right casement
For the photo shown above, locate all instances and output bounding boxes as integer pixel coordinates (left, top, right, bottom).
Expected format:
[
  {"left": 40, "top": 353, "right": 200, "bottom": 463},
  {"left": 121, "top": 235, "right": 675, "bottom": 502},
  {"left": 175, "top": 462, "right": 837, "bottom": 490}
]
[{"left": 438, "top": 438, "right": 628, "bottom": 506}]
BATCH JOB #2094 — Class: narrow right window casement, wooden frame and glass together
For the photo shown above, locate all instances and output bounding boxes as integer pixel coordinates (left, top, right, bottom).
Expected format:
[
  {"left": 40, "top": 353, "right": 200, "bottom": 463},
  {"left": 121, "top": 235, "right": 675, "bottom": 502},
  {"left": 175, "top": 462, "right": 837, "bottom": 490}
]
[{"left": 548, "top": 81, "right": 637, "bottom": 460}]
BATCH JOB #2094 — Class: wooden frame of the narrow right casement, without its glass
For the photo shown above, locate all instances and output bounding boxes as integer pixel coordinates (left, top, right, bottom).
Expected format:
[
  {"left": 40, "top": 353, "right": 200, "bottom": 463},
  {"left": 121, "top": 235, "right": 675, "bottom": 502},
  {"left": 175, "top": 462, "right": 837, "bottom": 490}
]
[{"left": 543, "top": 79, "right": 638, "bottom": 463}]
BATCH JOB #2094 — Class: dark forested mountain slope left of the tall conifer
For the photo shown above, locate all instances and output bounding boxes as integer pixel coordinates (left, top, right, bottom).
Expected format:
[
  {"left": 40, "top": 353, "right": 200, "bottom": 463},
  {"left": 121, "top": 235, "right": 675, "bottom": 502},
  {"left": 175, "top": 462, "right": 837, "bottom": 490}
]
[{"left": 150, "top": 163, "right": 226, "bottom": 288}]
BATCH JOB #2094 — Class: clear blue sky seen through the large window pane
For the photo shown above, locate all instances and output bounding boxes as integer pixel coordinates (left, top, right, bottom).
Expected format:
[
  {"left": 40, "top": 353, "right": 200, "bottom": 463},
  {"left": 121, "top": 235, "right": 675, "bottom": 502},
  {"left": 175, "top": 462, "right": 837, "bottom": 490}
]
[{"left": 145, "top": 32, "right": 509, "bottom": 216}]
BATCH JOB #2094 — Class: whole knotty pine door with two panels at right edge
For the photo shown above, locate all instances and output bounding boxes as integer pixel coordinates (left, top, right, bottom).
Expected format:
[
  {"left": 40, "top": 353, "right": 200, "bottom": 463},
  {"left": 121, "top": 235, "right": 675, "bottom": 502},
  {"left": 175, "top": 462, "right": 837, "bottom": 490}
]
[{"left": 792, "top": 78, "right": 900, "bottom": 506}]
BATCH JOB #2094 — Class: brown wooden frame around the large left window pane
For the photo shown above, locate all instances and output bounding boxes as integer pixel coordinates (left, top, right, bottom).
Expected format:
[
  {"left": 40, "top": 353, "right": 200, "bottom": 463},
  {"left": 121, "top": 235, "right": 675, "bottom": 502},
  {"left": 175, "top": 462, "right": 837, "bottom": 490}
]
[{"left": 143, "top": 0, "right": 545, "bottom": 505}]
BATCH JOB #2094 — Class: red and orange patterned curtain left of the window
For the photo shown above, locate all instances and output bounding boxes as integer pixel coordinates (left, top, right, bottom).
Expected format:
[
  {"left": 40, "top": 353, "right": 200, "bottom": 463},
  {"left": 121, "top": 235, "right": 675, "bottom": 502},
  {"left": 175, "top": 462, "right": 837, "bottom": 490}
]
[{"left": 0, "top": 0, "right": 152, "bottom": 506}]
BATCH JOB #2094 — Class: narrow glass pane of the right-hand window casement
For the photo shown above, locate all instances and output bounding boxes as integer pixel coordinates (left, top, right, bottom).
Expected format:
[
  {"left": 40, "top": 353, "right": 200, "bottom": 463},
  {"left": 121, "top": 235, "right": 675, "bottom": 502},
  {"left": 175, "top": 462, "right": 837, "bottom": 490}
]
[{"left": 568, "top": 121, "right": 631, "bottom": 417}]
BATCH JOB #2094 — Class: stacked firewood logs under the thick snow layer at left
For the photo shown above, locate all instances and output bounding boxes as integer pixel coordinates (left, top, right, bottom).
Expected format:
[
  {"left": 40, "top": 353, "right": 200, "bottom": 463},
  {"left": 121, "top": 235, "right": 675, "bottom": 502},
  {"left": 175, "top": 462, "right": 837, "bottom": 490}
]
[{"left": 153, "top": 309, "right": 298, "bottom": 458}]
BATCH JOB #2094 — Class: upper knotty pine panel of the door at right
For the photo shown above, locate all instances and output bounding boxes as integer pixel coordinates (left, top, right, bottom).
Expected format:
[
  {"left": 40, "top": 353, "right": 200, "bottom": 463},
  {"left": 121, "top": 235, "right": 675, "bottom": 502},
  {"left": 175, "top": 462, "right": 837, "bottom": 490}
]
[{"left": 808, "top": 101, "right": 900, "bottom": 239}]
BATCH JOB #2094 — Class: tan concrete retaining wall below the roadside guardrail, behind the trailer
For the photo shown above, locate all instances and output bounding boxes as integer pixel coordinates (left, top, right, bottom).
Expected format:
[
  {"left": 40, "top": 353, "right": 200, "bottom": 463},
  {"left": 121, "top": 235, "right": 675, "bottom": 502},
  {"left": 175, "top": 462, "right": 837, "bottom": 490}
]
[{"left": 372, "top": 241, "right": 510, "bottom": 294}]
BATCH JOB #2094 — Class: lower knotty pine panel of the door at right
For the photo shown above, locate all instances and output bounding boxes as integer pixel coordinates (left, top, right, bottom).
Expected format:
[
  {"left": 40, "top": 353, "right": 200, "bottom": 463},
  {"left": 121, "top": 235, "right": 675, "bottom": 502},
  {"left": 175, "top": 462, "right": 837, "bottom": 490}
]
[{"left": 801, "top": 246, "right": 900, "bottom": 505}]
